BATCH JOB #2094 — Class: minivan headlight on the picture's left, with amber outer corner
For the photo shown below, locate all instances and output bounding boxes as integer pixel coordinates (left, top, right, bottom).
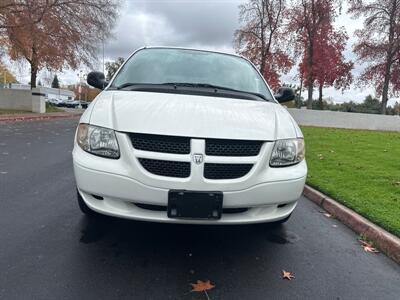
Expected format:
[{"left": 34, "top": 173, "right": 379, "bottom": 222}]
[{"left": 76, "top": 124, "right": 119, "bottom": 159}]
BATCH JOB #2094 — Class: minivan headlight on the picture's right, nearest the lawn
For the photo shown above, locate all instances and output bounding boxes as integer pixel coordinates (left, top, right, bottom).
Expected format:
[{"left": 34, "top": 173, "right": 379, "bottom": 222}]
[{"left": 269, "top": 139, "right": 305, "bottom": 167}]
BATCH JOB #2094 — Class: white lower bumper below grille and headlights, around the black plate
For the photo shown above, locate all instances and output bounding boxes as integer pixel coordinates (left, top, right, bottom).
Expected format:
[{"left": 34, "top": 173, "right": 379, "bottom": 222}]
[{"left": 74, "top": 162, "right": 306, "bottom": 224}]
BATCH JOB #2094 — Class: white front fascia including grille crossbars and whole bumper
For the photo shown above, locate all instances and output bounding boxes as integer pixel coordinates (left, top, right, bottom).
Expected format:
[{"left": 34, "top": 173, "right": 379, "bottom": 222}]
[{"left": 73, "top": 132, "right": 307, "bottom": 224}]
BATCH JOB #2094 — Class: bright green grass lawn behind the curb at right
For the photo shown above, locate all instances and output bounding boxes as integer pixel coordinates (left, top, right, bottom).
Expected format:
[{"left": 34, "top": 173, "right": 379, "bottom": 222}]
[{"left": 302, "top": 127, "right": 400, "bottom": 236}]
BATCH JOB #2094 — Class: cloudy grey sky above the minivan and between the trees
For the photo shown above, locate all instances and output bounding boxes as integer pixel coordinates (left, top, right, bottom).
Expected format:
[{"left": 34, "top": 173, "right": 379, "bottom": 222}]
[{"left": 7, "top": 0, "right": 393, "bottom": 104}]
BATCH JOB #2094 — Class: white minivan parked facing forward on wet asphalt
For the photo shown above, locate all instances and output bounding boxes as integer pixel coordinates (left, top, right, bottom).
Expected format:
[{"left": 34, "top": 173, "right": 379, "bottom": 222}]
[{"left": 73, "top": 47, "right": 307, "bottom": 224}]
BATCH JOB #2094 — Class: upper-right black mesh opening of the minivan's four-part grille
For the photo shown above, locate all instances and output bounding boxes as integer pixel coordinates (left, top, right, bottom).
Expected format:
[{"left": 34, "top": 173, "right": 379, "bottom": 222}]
[{"left": 206, "top": 139, "right": 263, "bottom": 156}]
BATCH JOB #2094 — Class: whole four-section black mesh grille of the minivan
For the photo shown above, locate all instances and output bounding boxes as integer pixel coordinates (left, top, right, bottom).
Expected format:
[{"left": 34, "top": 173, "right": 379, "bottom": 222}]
[{"left": 128, "top": 133, "right": 264, "bottom": 180}]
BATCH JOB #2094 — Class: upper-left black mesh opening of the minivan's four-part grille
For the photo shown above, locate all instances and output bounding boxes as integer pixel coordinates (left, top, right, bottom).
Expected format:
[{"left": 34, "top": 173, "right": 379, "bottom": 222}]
[{"left": 129, "top": 133, "right": 190, "bottom": 154}]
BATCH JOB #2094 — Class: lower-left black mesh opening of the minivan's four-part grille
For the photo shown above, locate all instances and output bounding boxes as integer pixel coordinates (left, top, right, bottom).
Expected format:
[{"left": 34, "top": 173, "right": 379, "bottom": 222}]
[{"left": 139, "top": 158, "right": 190, "bottom": 178}]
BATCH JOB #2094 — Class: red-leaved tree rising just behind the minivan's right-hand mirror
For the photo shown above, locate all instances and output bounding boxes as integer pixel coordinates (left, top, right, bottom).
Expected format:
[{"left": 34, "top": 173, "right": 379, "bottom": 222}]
[{"left": 235, "top": 0, "right": 293, "bottom": 89}]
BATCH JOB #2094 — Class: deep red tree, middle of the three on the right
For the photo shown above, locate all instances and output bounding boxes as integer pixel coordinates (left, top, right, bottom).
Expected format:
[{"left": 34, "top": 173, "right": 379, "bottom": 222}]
[{"left": 288, "top": 0, "right": 340, "bottom": 109}]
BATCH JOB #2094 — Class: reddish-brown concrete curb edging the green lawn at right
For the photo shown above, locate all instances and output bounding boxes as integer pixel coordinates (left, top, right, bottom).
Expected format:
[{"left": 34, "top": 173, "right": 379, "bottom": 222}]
[{"left": 303, "top": 185, "right": 400, "bottom": 264}]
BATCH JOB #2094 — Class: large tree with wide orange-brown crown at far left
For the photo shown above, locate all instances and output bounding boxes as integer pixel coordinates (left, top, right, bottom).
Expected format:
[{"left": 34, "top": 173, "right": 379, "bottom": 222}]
[{"left": 0, "top": 0, "right": 119, "bottom": 88}]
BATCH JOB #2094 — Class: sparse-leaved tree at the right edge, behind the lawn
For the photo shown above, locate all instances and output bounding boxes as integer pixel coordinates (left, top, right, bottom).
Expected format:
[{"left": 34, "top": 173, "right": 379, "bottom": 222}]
[{"left": 349, "top": 0, "right": 400, "bottom": 114}]
